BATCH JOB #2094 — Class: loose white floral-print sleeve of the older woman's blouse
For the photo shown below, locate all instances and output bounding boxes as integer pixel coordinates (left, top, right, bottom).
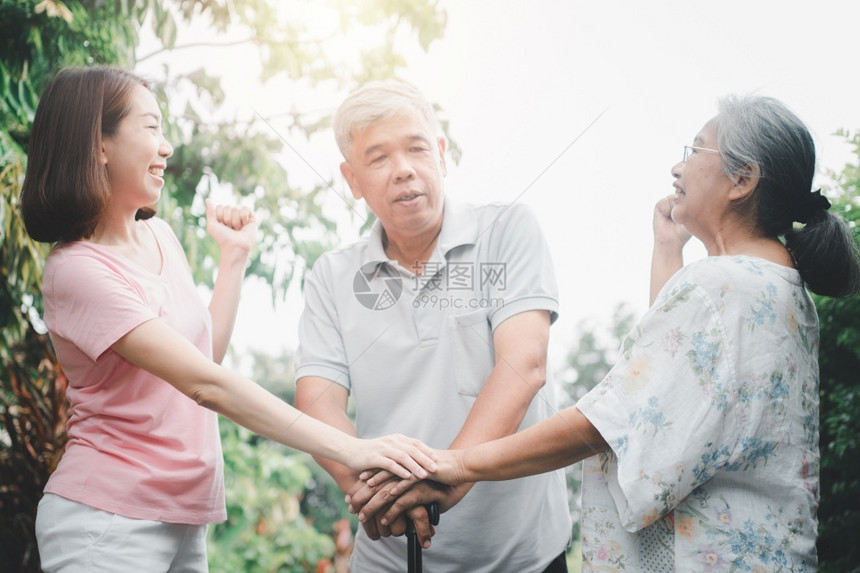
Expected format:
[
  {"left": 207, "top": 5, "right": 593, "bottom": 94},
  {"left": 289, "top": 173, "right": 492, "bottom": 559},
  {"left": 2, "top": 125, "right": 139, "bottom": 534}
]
[{"left": 577, "top": 281, "right": 739, "bottom": 532}]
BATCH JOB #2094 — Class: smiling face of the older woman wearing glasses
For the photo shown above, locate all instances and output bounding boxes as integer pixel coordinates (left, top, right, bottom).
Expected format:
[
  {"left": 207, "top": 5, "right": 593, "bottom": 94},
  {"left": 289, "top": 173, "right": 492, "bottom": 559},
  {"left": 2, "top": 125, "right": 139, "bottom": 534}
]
[{"left": 672, "top": 121, "right": 734, "bottom": 239}]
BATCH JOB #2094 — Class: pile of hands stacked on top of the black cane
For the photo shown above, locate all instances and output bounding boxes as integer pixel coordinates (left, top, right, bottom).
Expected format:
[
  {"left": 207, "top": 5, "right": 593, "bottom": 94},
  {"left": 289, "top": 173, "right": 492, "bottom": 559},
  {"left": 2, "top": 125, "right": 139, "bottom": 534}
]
[{"left": 345, "top": 446, "right": 464, "bottom": 549}]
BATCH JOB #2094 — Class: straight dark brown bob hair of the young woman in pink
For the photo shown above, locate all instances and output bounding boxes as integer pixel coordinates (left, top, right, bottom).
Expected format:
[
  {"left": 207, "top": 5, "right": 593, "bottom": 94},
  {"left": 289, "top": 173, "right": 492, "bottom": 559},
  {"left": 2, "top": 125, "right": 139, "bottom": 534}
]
[{"left": 21, "top": 67, "right": 155, "bottom": 243}]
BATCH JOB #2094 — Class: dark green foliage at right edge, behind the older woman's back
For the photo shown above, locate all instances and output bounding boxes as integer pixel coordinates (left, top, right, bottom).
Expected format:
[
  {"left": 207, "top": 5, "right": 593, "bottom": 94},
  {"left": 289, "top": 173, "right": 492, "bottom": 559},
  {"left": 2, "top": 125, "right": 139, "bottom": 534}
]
[{"left": 814, "top": 132, "right": 860, "bottom": 573}]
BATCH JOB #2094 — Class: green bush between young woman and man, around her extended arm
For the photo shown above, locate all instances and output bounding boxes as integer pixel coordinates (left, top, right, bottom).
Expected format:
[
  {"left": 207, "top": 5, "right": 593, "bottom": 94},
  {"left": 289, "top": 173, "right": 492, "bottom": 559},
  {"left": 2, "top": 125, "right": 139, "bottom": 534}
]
[{"left": 208, "top": 351, "right": 358, "bottom": 573}]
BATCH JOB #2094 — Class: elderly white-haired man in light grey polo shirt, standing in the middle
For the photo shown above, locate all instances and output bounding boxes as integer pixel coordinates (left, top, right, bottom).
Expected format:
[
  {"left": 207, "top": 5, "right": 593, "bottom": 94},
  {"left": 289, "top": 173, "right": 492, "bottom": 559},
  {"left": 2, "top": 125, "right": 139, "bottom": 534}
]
[{"left": 296, "top": 82, "right": 571, "bottom": 573}]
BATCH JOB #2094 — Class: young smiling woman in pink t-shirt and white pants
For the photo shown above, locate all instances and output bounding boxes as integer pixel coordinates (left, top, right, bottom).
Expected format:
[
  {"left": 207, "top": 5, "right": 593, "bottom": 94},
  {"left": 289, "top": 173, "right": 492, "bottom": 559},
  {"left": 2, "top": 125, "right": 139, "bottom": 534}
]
[{"left": 21, "top": 67, "right": 435, "bottom": 572}]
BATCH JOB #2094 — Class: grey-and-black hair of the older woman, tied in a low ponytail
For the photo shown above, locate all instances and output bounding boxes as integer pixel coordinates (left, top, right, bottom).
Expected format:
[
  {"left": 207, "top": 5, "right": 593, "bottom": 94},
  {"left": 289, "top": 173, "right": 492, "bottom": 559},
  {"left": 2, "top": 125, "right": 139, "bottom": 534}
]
[{"left": 713, "top": 96, "right": 860, "bottom": 296}]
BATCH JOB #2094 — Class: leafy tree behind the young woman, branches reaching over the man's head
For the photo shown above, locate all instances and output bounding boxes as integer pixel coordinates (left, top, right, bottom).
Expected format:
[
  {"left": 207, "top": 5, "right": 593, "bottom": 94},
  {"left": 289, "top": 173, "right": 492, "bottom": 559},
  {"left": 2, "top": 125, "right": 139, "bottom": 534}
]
[{"left": 0, "top": 0, "right": 445, "bottom": 571}]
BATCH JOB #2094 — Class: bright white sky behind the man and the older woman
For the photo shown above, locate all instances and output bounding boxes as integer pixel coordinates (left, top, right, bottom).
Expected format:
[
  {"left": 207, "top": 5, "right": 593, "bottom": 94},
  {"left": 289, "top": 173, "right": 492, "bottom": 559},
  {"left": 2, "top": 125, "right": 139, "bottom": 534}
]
[{"left": 142, "top": 0, "right": 860, "bottom": 370}]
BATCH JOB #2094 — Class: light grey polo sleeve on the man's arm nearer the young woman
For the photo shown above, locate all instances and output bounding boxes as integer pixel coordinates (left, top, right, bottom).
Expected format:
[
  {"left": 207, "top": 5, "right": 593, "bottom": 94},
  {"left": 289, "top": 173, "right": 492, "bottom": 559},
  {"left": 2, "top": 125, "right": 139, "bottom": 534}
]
[{"left": 296, "top": 255, "right": 350, "bottom": 389}]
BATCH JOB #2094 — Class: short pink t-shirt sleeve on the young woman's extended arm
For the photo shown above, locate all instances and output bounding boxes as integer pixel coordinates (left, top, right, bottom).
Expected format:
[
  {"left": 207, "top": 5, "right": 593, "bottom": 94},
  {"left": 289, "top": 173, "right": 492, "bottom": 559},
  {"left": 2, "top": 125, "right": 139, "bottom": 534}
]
[{"left": 45, "top": 255, "right": 158, "bottom": 361}]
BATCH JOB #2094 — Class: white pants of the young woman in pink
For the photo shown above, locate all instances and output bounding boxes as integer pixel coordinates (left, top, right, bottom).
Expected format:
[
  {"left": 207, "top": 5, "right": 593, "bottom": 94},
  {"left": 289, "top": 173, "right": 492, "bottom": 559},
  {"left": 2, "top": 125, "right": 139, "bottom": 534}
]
[{"left": 36, "top": 493, "right": 209, "bottom": 573}]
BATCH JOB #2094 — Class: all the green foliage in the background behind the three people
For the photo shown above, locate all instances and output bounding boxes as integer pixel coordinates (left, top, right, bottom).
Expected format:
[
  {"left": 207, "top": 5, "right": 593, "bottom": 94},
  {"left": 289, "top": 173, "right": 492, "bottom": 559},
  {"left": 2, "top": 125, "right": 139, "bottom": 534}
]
[{"left": 0, "top": 0, "right": 860, "bottom": 571}]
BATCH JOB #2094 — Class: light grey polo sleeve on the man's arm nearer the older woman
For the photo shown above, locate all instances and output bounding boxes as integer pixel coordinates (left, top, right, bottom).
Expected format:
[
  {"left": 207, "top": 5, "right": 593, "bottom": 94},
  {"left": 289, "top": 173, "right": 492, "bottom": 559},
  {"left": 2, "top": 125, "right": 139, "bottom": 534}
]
[{"left": 479, "top": 203, "right": 559, "bottom": 329}]
